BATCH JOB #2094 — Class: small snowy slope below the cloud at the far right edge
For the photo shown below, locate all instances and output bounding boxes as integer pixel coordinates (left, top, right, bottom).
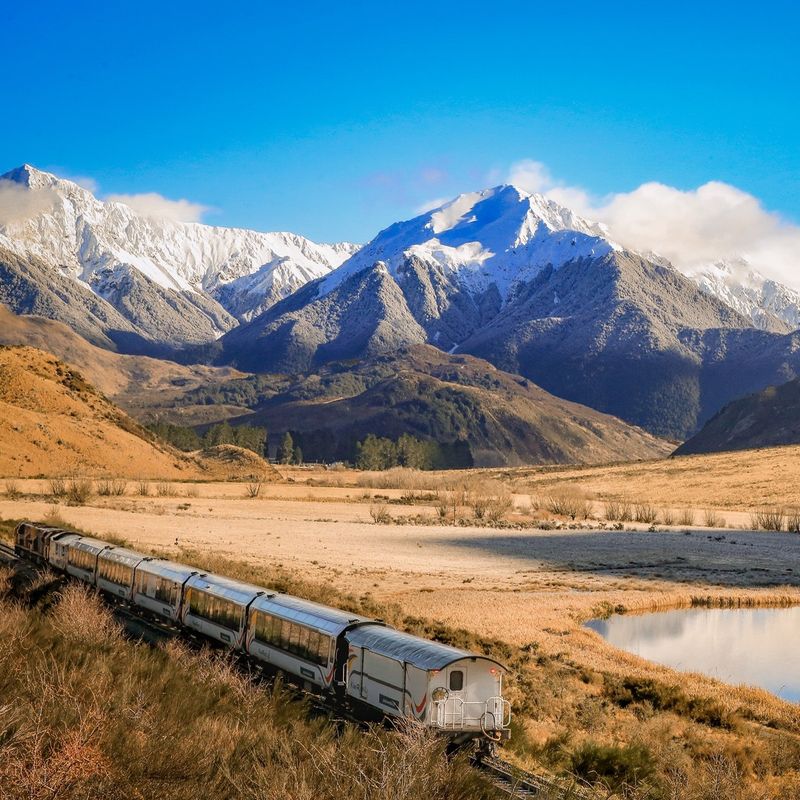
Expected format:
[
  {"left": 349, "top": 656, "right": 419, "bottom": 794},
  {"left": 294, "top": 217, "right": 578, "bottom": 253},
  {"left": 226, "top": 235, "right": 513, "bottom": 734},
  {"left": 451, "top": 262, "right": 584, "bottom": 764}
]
[{"left": 689, "top": 258, "right": 800, "bottom": 332}]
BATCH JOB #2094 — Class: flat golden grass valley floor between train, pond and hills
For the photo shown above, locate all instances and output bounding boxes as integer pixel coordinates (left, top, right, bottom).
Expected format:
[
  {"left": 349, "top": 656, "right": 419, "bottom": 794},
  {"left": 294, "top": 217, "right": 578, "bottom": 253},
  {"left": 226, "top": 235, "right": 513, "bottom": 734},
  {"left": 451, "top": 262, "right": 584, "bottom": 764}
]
[{"left": 0, "top": 462, "right": 800, "bottom": 797}]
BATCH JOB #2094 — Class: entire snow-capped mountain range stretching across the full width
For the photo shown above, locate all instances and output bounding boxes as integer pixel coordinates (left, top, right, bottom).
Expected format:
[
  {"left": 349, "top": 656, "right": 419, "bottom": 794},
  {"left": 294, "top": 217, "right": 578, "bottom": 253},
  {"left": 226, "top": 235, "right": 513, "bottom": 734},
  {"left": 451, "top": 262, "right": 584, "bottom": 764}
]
[{"left": 0, "top": 166, "right": 800, "bottom": 446}]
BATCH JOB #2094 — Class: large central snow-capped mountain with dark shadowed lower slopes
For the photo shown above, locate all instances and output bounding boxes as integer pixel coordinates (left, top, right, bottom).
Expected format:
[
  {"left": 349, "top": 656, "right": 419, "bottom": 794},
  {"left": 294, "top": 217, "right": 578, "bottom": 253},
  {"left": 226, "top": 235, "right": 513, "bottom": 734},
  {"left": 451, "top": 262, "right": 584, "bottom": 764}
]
[{"left": 221, "top": 186, "right": 800, "bottom": 438}]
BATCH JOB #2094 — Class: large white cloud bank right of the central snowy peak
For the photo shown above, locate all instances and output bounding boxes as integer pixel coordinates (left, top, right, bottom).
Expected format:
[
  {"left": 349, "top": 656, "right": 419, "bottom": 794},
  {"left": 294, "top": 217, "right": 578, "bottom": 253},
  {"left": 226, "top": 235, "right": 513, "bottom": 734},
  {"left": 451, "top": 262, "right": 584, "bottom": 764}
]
[{"left": 507, "top": 160, "right": 800, "bottom": 288}]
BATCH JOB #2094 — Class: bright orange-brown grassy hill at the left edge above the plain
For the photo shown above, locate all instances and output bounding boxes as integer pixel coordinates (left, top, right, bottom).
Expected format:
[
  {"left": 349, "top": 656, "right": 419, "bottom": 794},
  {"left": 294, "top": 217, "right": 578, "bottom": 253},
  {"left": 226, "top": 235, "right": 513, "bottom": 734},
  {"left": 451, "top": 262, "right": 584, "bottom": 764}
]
[{"left": 0, "top": 347, "right": 275, "bottom": 479}]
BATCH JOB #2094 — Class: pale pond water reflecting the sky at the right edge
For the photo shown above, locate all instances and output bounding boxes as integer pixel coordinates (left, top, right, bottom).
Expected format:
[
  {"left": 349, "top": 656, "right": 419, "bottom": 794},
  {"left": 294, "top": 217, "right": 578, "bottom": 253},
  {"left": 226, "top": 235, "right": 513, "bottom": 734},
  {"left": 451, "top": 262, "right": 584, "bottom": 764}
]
[{"left": 587, "top": 607, "right": 800, "bottom": 703}]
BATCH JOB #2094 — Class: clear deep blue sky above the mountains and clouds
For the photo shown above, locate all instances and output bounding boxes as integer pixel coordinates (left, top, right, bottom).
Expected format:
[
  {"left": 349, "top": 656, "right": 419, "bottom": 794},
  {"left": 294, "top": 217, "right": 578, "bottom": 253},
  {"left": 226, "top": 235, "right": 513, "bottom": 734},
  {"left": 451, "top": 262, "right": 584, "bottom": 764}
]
[{"left": 0, "top": 0, "right": 800, "bottom": 241}]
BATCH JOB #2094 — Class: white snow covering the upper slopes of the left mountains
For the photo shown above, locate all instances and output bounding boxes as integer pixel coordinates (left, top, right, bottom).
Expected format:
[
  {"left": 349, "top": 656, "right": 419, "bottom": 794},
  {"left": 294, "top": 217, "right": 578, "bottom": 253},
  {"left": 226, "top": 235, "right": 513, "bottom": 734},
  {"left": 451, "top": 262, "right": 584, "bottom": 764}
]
[{"left": 0, "top": 165, "right": 357, "bottom": 319}]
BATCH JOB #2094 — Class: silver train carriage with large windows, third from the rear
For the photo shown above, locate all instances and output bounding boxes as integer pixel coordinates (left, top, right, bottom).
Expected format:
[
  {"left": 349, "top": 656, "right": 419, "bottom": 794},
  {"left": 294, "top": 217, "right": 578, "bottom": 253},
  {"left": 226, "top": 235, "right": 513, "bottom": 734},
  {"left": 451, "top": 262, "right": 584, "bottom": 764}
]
[{"left": 181, "top": 574, "right": 267, "bottom": 649}]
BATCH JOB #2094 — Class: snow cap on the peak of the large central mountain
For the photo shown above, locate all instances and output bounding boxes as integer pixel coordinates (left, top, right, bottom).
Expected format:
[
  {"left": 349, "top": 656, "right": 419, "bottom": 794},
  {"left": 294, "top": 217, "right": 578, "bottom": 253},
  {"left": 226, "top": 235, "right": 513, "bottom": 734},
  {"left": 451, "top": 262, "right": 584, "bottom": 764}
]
[{"left": 318, "top": 185, "right": 619, "bottom": 299}]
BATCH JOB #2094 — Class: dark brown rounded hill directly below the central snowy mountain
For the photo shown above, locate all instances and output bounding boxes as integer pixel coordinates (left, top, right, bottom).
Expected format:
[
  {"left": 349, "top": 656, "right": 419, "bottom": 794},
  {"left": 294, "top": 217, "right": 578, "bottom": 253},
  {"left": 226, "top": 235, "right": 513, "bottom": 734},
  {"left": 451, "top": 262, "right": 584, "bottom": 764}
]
[{"left": 240, "top": 345, "right": 673, "bottom": 466}]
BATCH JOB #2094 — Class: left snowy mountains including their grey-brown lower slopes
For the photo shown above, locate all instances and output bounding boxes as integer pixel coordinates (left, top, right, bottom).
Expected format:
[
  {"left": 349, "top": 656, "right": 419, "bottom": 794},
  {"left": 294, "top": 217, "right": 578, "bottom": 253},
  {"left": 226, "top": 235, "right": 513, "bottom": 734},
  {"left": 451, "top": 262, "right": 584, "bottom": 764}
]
[{"left": 0, "top": 165, "right": 357, "bottom": 352}]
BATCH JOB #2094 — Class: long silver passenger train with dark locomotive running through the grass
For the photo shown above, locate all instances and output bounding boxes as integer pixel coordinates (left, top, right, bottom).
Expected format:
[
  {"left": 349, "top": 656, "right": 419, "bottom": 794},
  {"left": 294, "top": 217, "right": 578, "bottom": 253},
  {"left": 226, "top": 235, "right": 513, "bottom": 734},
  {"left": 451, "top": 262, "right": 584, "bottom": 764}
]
[{"left": 15, "top": 522, "right": 511, "bottom": 747}]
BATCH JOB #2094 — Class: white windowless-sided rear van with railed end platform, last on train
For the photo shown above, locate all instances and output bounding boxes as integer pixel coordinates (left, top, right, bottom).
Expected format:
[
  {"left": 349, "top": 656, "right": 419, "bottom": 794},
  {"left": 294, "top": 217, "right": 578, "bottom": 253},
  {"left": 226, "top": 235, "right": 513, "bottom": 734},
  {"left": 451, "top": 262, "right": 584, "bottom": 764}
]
[{"left": 345, "top": 625, "right": 511, "bottom": 740}]
